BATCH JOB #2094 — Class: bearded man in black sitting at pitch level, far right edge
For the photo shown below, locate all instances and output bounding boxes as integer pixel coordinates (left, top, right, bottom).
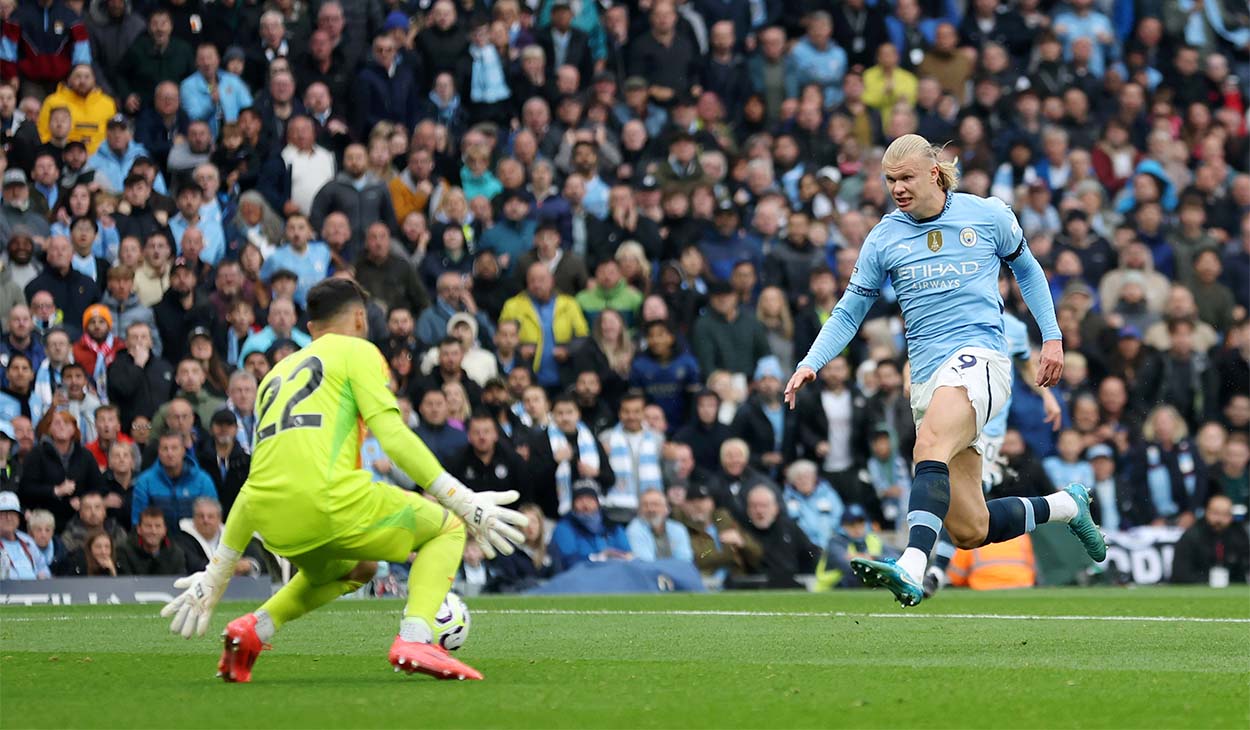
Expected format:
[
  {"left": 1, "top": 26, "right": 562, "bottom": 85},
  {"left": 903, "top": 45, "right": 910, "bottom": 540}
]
[{"left": 1171, "top": 494, "right": 1250, "bottom": 585}]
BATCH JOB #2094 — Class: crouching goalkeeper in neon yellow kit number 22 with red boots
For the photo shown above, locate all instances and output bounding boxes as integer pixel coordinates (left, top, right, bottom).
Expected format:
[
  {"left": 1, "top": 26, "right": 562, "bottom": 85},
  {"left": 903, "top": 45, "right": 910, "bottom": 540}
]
[{"left": 161, "top": 279, "right": 528, "bottom": 681}]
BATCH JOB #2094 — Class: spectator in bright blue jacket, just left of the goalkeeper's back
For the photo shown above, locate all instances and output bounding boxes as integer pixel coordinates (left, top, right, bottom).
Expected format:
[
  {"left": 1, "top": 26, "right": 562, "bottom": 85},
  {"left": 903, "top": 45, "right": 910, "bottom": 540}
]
[{"left": 130, "top": 431, "right": 218, "bottom": 527}]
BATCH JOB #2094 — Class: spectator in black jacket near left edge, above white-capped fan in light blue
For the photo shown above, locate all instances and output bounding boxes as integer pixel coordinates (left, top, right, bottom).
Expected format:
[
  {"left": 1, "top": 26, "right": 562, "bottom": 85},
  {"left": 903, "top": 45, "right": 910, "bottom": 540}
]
[{"left": 18, "top": 407, "right": 105, "bottom": 528}]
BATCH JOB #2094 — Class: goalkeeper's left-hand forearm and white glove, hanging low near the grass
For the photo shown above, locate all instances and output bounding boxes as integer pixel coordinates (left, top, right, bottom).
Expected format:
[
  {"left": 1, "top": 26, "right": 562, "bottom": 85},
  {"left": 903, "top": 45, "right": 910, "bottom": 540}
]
[{"left": 160, "top": 493, "right": 251, "bottom": 639}]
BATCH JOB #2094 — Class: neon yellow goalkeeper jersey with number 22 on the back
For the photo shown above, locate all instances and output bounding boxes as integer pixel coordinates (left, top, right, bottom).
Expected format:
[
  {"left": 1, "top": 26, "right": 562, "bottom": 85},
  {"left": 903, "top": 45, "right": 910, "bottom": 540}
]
[{"left": 244, "top": 334, "right": 441, "bottom": 555}]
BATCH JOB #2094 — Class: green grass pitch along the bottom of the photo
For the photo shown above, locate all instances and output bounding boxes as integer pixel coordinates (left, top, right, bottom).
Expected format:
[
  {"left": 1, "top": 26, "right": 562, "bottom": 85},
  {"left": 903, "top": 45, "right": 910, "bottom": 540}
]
[{"left": 0, "top": 586, "right": 1250, "bottom": 730}]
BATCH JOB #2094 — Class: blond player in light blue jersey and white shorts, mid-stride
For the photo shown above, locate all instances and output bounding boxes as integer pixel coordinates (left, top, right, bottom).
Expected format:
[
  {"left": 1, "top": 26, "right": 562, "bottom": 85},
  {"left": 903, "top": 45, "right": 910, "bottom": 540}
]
[{"left": 785, "top": 135, "right": 1106, "bottom": 606}]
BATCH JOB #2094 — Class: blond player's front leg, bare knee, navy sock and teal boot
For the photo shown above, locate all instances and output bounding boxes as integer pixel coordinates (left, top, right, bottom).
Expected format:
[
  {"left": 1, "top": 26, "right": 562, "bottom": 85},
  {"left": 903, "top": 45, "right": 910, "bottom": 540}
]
[{"left": 851, "top": 385, "right": 984, "bottom": 606}]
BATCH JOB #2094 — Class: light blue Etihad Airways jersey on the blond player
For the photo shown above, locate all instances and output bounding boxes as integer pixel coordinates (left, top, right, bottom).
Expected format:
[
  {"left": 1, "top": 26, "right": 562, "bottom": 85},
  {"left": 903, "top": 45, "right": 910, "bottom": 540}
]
[{"left": 799, "top": 193, "right": 1060, "bottom": 383}]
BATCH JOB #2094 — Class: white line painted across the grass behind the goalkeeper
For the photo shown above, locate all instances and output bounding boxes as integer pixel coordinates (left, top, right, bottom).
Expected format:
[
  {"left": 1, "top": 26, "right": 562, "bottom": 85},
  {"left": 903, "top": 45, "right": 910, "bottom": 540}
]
[{"left": 7, "top": 609, "right": 1250, "bottom": 625}]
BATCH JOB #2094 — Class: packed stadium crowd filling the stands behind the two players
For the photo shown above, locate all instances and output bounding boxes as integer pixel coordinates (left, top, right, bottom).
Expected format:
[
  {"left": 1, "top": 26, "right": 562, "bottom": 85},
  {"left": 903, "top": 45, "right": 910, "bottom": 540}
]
[{"left": 0, "top": 0, "right": 1250, "bottom": 590}]
